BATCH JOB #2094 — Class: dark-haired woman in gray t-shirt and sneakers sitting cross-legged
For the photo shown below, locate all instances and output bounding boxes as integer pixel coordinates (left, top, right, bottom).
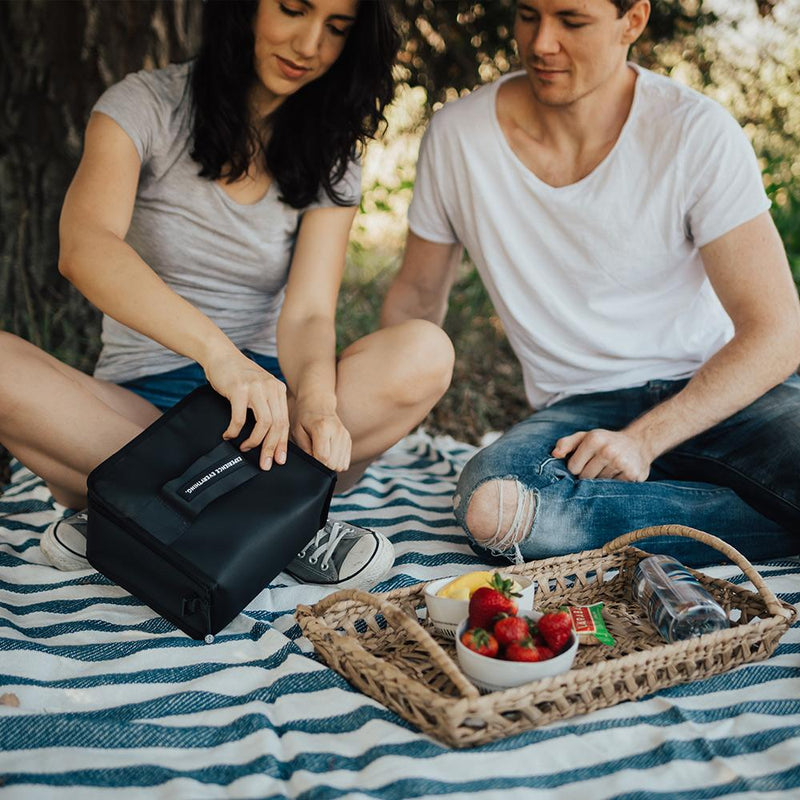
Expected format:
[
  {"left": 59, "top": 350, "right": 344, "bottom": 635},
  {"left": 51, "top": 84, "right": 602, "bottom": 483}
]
[{"left": 0, "top": 0, "right": 452, "bottom": 586}]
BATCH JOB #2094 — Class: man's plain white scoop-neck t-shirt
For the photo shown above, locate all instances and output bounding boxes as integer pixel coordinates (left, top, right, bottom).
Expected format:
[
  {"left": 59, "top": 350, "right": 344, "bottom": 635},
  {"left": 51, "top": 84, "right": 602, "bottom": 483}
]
[{"left": 408, "top": 65, "right": 770, "bottom": 408}]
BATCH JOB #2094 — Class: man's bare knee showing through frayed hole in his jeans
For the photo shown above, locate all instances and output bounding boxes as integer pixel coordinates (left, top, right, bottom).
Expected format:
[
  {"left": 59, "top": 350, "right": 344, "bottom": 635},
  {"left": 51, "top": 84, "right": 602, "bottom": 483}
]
[{"left": 465, "top": 478, "right": 536, "bottom": 552}]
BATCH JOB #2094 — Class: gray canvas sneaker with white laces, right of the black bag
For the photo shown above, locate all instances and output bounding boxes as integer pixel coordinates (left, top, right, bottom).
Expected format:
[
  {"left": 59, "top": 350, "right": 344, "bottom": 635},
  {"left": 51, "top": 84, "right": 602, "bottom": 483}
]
[{"left": 286, "top": 519, "right": 394, "bottom": 589}]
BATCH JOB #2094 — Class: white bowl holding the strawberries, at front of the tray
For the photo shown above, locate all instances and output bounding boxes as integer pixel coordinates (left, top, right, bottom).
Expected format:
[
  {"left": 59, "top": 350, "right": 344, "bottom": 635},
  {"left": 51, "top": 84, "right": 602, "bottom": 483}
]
[{"left": 456, "top": 611, "right": 578, "bottom": 692}]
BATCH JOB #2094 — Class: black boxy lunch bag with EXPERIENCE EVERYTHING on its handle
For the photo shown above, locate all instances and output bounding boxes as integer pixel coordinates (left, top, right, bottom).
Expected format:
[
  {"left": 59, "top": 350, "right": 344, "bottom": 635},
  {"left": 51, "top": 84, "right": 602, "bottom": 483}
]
[{"left": 87, "top": 385, "right": 336, "bottom": 641}]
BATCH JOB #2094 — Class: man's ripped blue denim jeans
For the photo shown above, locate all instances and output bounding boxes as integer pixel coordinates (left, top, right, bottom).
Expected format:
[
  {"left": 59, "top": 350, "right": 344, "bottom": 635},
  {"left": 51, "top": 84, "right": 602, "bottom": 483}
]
[{"left": 453, "top": 375, "right": 800, "bottom": 566}]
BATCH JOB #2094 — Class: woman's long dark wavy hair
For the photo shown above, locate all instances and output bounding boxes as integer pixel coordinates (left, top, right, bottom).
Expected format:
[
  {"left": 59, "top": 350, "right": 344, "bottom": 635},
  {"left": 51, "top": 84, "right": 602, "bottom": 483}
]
[{"left": 191, "top": 0, "right": 400, "bottom": 208}]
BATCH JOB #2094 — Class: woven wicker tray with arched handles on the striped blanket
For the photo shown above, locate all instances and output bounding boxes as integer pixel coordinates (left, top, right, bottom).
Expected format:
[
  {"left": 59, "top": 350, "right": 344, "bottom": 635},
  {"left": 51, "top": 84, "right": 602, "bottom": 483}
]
[{"left": 296, "top": 525, "right": 797, "bottom": 747}]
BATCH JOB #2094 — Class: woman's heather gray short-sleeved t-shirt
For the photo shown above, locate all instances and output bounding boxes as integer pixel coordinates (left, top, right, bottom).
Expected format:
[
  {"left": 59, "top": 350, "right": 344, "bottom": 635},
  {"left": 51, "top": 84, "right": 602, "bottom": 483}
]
[{"left": 93, "top": 64, "right": 361, "bottom": 383}]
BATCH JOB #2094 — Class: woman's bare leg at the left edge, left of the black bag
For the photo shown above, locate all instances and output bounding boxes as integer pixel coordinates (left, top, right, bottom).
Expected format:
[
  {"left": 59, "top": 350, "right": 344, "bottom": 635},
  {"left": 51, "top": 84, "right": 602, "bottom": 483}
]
[{"left": 0, "top": 332, "right": 161, "bottom": 508}]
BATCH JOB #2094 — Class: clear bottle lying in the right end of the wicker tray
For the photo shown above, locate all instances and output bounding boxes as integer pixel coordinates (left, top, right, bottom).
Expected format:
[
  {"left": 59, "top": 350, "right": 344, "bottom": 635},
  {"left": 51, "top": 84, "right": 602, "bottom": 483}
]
[{"left": 633, "top": 555, "right": 730, "bottom": 642}]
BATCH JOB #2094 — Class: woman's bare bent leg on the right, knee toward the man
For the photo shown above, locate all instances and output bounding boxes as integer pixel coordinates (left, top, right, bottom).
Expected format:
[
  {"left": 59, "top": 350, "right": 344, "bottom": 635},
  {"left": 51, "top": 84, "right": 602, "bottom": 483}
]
[{"left": 336, "top": 320, "right": 454, "bottom": 491}]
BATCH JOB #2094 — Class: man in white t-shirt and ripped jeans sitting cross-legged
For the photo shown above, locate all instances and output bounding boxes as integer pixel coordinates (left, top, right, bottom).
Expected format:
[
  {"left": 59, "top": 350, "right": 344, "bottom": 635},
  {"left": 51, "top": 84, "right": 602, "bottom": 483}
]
[{"left": 382, "top": 0, "right": 800, "bottom": 564}]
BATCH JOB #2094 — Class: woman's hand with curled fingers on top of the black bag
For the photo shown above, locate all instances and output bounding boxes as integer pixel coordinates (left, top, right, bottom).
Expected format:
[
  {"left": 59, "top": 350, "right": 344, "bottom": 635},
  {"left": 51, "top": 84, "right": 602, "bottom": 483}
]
[{"left": 205, "top": 350, "right": 289, "bottom": 469}]
